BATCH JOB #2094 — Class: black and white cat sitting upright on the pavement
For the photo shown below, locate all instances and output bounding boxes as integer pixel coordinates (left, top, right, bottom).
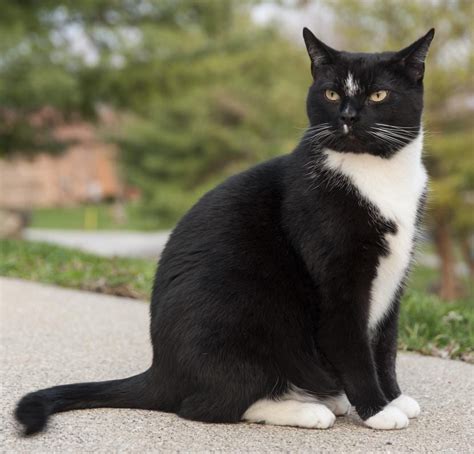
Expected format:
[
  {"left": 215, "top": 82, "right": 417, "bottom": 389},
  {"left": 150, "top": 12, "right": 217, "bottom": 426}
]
[{"left": 16, "top": 29, "right": 434, "bottom": 434}]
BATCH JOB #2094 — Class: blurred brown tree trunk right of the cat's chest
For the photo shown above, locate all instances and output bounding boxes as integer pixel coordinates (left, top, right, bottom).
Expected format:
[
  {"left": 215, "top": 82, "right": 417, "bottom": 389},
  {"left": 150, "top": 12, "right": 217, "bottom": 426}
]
[{"left": 434, "top": 220, "right": 458, "bottom": 301}]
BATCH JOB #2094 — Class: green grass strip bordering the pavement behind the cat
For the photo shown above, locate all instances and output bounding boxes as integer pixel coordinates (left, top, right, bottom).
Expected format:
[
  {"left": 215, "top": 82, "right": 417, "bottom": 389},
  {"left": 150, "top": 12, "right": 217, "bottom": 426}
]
[{"left": 0, "top": 240, "right": 474, "bottom": 362}]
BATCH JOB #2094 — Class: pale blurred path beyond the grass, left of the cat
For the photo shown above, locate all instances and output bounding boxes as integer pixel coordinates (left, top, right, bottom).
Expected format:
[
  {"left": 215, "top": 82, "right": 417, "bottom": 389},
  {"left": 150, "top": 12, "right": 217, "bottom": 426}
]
[{"left": 24, "top": 229, "right": 170, "bottom": 259}]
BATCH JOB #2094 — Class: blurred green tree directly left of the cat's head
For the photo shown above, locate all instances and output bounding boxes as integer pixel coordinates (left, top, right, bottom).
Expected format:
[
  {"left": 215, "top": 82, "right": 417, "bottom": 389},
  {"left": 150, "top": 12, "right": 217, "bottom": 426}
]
[{"left": 109, "top": 2, "right": 309, "bottom": 222}]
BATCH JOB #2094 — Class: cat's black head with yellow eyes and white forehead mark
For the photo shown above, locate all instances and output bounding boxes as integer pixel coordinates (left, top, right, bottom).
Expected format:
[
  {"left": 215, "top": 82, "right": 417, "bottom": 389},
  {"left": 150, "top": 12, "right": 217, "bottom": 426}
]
[{"left": 303, "top": 28, "right": 434, "bottom": 157}]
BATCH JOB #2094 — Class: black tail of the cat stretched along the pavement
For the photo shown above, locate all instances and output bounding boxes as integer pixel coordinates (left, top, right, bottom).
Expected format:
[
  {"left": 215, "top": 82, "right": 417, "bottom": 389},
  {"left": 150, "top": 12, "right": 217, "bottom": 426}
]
[{"left": 15, "top": 371, "right": 155, "bottom": 435}]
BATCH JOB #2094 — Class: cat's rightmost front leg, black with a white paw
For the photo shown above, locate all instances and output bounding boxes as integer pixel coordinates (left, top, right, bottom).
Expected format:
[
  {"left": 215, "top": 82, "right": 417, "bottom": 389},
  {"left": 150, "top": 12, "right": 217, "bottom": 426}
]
[{"left": 373, "top": 304, "right": 421, "bottom": 418}]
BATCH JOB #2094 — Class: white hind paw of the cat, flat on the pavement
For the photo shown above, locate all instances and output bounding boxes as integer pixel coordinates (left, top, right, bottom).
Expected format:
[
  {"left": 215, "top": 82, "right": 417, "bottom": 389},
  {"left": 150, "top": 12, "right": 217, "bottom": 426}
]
[{"left": 242, "top": 399, "right": 336, "bottom": 429}]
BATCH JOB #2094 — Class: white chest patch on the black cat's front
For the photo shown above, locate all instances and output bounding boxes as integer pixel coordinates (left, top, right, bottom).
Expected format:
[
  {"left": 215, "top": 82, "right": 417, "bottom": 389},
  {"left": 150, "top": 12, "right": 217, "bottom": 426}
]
[{"left": 325, "top": 132, "right": 427, "bottom": 328}]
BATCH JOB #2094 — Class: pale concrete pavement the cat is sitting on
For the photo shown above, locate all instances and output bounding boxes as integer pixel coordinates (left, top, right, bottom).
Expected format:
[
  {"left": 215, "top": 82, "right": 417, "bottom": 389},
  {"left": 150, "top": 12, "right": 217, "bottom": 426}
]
[{"left": 0, "top": 278, "right": 474, "bottom": 454}]
